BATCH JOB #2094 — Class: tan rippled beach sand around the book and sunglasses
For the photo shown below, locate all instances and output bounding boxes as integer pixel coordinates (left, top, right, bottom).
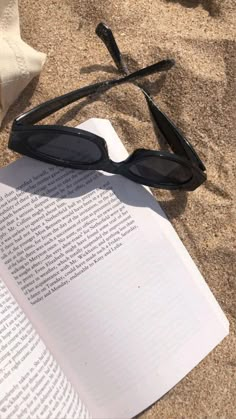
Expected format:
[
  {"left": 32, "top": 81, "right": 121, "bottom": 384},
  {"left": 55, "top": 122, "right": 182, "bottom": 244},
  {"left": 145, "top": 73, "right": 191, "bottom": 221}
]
[{"left": 0, "top": 0, "right": 236, "bottom": 419}]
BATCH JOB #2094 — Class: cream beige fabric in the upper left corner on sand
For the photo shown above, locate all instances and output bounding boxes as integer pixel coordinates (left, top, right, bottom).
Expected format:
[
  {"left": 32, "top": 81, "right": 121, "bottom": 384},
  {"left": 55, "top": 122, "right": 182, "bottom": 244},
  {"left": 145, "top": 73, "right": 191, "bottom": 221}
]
[{"left": 0, "top": 0, "right": 46, "bottom": 125}]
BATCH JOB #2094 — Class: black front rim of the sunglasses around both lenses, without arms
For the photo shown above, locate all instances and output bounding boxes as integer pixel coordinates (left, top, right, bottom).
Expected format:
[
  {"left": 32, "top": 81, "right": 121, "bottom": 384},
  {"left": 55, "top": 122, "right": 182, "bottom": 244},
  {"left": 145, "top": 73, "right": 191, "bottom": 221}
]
[{"left": 9, "top": 123, "right": 203, "bottom": 191}]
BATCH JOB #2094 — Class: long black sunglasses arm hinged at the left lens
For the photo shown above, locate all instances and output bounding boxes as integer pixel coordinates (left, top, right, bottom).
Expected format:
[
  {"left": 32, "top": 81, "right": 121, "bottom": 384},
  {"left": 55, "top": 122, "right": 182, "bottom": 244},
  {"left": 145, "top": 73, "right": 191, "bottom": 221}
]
[{"left": 15, "top": 60, "right": 173, "bottom": 125}]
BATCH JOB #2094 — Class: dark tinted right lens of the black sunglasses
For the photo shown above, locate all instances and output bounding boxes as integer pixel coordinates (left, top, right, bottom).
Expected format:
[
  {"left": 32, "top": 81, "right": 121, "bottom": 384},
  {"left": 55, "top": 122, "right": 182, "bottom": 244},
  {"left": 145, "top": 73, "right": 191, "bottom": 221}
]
[{"left": 129, "top": 156, "right": 192, "bottom": 185}]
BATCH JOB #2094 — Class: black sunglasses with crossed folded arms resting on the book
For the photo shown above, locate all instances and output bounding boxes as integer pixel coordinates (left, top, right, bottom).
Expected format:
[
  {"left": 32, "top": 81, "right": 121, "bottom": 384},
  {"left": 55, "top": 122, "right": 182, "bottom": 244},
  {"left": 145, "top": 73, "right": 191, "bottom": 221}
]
[{"left": 8, "top": 23, "right": 206, "bottom": 190}]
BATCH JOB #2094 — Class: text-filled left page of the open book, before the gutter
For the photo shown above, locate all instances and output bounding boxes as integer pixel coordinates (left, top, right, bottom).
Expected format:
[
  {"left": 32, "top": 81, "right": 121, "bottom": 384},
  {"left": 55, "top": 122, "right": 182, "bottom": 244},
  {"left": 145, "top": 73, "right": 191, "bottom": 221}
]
[{"left": 0, "top": 270, "right": 89, "bottom": 419}]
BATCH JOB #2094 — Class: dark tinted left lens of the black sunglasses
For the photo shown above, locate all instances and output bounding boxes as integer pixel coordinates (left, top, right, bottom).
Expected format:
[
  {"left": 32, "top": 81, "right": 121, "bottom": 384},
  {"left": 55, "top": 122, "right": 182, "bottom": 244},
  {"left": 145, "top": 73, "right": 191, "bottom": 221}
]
[{"left": 27, "top": 131, "right": 102, "bottom": 164}]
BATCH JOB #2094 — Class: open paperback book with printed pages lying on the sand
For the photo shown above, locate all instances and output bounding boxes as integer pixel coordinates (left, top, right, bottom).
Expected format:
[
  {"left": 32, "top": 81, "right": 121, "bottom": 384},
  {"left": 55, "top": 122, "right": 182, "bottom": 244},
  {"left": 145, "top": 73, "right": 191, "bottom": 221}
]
[{"left": 0, "top": 119, "right": 228, "bottom": 419}]
